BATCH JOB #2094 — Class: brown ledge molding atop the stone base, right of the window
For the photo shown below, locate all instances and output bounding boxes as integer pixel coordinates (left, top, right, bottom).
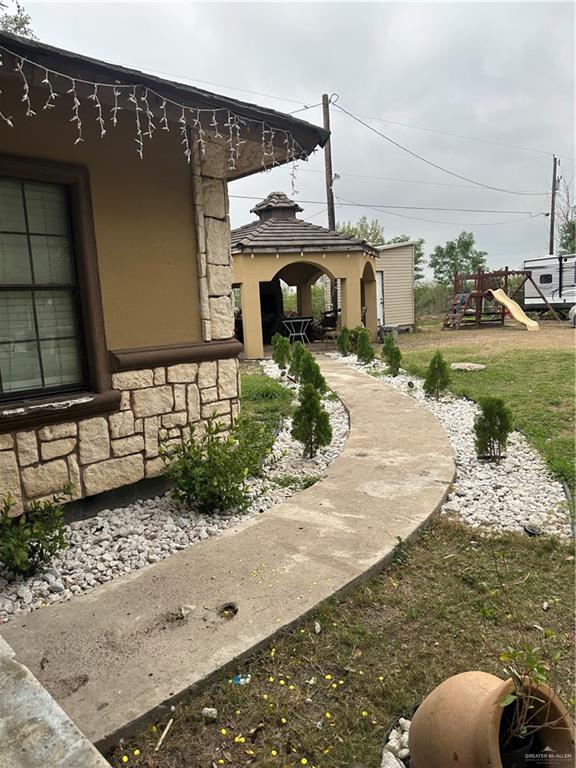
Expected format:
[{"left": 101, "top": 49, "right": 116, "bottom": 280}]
[{"left": 110, "top": 339, "right": 244, "bottom": 372}]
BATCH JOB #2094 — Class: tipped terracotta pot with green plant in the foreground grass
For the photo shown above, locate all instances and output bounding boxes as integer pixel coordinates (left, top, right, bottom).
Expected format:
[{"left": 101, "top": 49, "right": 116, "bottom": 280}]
[{"left": 410, "top": 644, "right": 574, "bottom": 768}]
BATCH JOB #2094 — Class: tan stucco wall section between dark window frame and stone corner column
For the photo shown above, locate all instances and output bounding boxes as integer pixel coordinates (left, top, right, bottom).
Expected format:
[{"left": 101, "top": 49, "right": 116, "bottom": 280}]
[{"left": 0, "top": 78, "right": 202, "bottom": 349}]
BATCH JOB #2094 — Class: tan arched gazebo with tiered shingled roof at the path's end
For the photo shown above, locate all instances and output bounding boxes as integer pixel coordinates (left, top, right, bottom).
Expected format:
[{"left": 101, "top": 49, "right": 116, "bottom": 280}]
[{"left": 231, "top": 192, "right": 378, "bottom": 358}]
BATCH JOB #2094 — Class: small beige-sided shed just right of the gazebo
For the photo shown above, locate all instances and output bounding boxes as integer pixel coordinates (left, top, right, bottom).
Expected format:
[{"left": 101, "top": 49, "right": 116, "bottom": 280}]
[{"left": 376, "top": 245, "right": 414, "bottom": 325}]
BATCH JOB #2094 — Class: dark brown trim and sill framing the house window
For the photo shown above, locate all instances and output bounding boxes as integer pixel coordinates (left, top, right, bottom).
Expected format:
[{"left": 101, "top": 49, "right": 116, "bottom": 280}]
[{"left": 0, "top": 155, "right": 120, "bottom": 433}]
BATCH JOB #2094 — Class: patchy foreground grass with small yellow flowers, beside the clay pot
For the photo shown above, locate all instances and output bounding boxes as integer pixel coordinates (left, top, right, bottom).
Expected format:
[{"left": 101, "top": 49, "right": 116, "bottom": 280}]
[{"left": 110, "top": 518, "right": 574, "bottom": 768}]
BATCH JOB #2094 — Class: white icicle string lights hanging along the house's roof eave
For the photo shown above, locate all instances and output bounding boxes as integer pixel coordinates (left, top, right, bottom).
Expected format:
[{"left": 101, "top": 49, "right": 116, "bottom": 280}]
[{"left": 0, "top": 46, "right": 307, "bottom": 174}]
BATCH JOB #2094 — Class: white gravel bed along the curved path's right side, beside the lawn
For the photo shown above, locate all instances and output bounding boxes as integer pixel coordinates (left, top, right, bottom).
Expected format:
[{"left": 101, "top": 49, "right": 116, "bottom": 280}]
[{"left": 330, "top": 353, "right": 572, "bottom": 537}]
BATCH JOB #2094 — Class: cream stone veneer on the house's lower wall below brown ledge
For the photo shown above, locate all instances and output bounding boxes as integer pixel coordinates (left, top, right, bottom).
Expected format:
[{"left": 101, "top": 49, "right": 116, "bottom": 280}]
[{"left": 0, "top": 359, "right": 238, "bottom": 514}]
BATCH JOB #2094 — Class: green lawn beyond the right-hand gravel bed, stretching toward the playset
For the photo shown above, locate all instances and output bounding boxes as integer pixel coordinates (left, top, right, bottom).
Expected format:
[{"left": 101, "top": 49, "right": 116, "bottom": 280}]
[{"left": 400, "top": 326, "right": 576, "bottom": 493}]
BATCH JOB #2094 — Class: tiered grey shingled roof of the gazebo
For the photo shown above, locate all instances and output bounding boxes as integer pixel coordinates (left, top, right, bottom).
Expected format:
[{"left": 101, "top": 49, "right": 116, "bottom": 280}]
[{"left": 231, "top": 192, "right": 378, "bottom": 256}]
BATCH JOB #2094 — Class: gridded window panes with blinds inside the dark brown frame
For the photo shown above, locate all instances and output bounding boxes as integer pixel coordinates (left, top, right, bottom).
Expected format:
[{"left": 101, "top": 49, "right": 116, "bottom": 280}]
[{"left": 0, "top": 178, "right": 84, "bottom": 399}]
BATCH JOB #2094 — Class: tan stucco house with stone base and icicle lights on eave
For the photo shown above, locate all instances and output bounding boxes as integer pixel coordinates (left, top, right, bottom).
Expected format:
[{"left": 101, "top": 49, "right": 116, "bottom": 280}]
[{"left": 0, "top": 33, "right": 328, "bottom": 512}]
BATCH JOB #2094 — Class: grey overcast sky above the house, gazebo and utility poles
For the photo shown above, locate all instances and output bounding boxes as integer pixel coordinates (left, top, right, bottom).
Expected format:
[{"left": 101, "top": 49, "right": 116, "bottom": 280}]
[{"left": 24, "top": 0, "right": 575, "bottom": 267}]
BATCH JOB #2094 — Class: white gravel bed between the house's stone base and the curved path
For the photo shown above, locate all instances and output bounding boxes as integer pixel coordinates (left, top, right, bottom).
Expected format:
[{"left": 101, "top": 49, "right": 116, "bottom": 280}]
[{"left": 0, "top": 362, "right": 349, "bottom": 625}]
